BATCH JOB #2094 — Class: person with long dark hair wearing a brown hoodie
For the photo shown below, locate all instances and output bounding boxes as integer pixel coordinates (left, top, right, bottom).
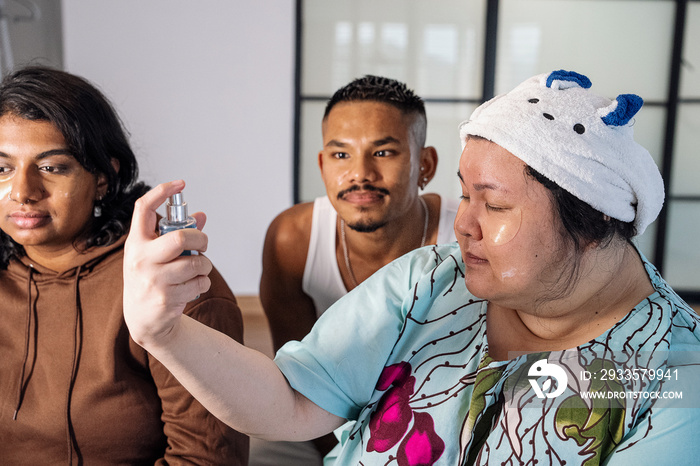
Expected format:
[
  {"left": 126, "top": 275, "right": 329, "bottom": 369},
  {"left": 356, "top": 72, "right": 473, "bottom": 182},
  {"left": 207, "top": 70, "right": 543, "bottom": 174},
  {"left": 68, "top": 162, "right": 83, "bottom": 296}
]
[{"left": 0, "top": 67, "right": 248, "bottom": 465}]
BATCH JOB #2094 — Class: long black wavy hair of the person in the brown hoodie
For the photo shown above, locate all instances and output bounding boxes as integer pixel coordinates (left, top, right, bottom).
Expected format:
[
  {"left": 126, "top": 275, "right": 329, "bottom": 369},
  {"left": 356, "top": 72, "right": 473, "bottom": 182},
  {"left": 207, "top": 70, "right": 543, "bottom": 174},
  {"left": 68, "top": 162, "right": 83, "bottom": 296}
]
[{"left": 0, "top": 66, "right": 149, "bottom": 269}]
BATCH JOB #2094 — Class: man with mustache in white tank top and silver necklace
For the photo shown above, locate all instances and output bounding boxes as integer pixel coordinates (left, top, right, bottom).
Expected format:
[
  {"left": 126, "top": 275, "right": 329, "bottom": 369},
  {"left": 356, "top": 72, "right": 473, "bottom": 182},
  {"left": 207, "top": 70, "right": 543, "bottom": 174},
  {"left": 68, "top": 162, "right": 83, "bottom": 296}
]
[{"left": 250, "top": 76, "right": 459, "bottom": 466}]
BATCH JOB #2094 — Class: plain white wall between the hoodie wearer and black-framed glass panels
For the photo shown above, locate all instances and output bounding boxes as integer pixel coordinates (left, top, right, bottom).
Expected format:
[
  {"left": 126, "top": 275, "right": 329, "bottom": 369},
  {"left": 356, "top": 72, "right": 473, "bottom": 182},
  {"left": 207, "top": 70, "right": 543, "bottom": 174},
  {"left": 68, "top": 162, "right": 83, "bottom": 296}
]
[{"left": 62, "top": 0, "right": 295, "bottom": 294}]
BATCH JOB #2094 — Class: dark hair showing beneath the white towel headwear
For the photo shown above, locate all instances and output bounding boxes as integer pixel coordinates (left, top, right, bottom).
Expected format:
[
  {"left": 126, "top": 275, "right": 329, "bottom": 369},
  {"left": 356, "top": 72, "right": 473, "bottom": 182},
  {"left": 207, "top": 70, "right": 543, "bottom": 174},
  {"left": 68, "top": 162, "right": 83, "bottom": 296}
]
[{"left": 525, "top": 165, "right": 637, "bottom": 252}]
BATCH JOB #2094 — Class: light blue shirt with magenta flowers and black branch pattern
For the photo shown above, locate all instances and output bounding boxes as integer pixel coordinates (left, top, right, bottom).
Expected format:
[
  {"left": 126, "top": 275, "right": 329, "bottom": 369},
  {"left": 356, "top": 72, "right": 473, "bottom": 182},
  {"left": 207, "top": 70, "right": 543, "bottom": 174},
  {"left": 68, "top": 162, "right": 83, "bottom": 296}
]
[{"left": 275, "top": 243, "right": 700, "bottom": 466}]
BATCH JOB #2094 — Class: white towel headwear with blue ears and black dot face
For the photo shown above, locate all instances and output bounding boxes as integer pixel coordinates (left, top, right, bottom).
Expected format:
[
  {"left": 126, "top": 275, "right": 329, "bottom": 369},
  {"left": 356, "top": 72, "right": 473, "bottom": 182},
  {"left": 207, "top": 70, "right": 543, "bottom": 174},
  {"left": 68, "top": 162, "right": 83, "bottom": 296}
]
[{"left": 459, "top": 70, "right": 664, "bottom": 235}]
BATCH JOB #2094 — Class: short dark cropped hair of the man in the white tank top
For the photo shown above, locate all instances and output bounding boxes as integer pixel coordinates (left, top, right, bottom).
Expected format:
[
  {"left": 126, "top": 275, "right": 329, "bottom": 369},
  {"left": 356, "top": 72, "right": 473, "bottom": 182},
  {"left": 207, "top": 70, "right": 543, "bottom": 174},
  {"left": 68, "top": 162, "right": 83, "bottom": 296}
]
[{"left": 323, "top": 75, "right": 427, "bottom": 147}]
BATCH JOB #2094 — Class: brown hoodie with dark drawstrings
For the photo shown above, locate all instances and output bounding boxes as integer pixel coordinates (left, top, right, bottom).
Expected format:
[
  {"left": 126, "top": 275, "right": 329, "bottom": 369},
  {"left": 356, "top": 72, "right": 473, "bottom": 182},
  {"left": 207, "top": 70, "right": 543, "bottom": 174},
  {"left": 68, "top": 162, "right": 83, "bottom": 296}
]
[{"left": 0, "top": 238, "right": 248, "bottom": 465}]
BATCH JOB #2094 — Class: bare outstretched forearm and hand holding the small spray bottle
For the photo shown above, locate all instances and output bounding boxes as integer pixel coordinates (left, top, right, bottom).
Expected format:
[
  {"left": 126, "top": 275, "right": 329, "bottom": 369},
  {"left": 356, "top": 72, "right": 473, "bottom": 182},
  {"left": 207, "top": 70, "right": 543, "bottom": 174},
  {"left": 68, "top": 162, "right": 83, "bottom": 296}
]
[{"left": 124, "top": 181, "right": 344, "bottom": 440}]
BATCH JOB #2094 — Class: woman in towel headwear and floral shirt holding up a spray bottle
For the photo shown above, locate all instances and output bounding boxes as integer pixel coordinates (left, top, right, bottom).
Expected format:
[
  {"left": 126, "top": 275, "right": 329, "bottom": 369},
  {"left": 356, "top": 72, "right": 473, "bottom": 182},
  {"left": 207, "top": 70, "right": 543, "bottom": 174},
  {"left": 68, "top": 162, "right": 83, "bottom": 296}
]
[{"left": 124, "top": 71, "right": 700, "bottom": 466}]
